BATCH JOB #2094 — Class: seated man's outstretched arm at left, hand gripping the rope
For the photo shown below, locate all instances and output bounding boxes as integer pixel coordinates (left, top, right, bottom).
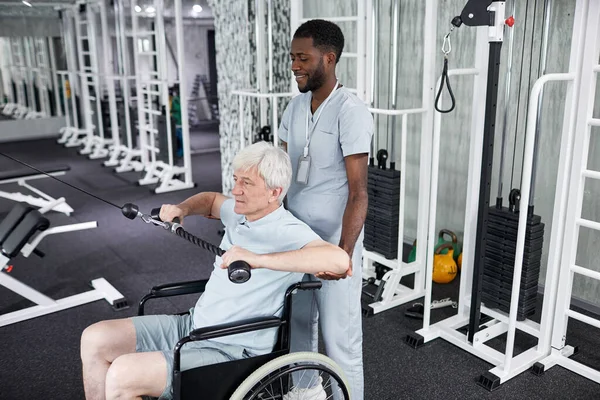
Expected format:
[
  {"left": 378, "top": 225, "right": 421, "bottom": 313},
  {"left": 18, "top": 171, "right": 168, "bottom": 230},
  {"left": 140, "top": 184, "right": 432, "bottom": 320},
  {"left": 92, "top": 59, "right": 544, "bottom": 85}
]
[{"left": 160, "top": 192, "right": 228, "bottom": 222}]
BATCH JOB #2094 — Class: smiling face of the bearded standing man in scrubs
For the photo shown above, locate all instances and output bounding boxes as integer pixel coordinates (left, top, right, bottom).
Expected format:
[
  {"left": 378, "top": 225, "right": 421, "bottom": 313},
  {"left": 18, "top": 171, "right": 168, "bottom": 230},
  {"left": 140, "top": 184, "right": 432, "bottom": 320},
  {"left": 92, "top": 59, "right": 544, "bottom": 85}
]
[{"left": 290, "top": 38, "right": 335, "bottom": 93}]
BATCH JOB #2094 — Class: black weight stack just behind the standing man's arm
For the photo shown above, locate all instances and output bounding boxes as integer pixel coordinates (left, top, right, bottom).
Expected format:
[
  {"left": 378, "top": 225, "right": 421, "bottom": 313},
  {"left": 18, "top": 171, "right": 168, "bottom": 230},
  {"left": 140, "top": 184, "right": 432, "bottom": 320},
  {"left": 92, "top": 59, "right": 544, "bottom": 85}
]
[{"left": 364, "top": 167, "right": 400, "bottom": 259}]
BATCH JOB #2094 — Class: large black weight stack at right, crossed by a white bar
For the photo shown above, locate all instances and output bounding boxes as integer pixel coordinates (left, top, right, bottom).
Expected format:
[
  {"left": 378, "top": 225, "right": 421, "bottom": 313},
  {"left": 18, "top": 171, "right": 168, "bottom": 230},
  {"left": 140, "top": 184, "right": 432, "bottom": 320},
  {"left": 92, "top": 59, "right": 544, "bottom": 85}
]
[{"left": 481, "top": 207, "right": 544, "bottom": 321}]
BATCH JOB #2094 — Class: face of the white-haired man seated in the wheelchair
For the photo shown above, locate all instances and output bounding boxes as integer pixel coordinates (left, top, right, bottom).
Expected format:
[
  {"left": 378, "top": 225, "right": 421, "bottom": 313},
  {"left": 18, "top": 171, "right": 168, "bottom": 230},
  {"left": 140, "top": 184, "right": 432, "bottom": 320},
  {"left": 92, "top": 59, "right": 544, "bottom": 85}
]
[{"left": 231, "top": 167, "right": 282, "bottom": 222}]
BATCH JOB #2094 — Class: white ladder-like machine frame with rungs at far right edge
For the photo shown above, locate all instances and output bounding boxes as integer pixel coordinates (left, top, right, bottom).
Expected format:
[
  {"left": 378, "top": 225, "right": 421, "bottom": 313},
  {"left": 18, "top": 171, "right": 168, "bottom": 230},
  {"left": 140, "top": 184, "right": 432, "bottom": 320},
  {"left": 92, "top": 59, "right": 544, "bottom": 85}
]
[{"left": 534, "top": 1, "right": 600, "bottom": 383}]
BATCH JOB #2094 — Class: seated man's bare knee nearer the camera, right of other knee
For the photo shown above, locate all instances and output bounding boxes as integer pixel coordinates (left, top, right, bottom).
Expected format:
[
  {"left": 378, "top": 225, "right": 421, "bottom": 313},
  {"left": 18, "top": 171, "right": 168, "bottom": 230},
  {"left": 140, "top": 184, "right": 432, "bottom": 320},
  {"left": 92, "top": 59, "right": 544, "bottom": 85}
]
[{"left": 106, "top": 351, "right": 168, "bottom": 400}]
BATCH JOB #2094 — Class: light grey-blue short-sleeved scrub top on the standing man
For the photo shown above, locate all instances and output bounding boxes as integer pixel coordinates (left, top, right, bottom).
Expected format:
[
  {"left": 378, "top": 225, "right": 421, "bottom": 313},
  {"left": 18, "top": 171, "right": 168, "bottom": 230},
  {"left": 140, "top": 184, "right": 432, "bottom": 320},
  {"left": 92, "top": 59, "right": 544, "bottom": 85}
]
[{"left": 279, "top": 87, "right": 374, "bottom": 245}]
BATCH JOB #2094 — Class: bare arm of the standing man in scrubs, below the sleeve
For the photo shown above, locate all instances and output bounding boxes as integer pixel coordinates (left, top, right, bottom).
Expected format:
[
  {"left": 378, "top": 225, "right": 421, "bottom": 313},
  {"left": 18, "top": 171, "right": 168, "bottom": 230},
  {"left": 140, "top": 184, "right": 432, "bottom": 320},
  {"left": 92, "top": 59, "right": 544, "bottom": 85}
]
[{"left": 339, "top": 153, "right": 369, "bottom": 257}]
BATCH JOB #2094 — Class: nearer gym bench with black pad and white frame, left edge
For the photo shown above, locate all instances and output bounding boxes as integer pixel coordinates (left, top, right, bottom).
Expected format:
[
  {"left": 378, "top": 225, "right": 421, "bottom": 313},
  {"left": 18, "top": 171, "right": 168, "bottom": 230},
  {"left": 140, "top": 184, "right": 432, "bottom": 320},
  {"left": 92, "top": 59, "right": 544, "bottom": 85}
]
[{"left": 0, "top": 203, "right": 127, "bottom": 327}]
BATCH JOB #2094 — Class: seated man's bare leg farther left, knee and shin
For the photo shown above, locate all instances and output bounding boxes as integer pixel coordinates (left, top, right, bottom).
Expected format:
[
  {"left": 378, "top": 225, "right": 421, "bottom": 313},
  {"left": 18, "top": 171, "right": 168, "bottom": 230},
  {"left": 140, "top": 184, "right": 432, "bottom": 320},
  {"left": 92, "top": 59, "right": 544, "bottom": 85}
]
[{"left": 81, "top": 319, "right": 136, "bottom": 400}]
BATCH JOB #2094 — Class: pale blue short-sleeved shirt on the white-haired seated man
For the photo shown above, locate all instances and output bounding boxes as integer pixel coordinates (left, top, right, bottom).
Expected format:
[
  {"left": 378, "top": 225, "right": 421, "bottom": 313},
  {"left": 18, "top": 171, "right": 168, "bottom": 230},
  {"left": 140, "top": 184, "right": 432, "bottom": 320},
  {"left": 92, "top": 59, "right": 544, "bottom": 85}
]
[{"left": 193, "top": 199, "right": 320, "bottom": 355}]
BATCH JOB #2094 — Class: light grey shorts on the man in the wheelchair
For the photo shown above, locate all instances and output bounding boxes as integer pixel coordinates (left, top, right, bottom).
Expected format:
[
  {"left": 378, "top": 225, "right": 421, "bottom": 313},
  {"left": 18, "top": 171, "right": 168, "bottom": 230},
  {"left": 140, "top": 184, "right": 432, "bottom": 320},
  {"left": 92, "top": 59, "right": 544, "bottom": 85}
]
[{"left": 132, "top": 309, "right": 248, "bottom": 399}]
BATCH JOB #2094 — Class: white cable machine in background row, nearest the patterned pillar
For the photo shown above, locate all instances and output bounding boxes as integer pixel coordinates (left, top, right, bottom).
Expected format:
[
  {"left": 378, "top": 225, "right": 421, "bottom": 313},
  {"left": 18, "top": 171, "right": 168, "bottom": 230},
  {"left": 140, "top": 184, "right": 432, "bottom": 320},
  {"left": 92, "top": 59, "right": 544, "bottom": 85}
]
[{"left": 131, "top": 0, "right": 194, "bottom": 193}]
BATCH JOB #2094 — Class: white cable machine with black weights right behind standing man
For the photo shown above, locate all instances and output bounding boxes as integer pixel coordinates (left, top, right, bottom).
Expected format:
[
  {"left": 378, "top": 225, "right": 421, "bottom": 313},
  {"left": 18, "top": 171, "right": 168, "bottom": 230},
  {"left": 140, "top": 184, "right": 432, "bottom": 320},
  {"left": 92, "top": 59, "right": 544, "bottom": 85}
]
[{"left": 362, "top": 0, "right": 438, "bottom": 316}]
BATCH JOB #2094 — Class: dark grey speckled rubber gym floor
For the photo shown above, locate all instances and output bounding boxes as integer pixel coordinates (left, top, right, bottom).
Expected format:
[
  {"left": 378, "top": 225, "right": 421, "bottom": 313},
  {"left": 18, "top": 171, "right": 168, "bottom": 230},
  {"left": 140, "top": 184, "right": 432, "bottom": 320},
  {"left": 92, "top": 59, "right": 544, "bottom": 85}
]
[{"left": 0, "top": 136, "right": 600, "bottom": 400}]
